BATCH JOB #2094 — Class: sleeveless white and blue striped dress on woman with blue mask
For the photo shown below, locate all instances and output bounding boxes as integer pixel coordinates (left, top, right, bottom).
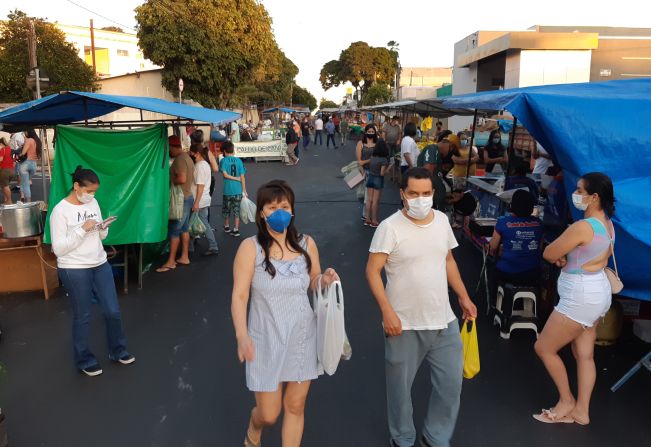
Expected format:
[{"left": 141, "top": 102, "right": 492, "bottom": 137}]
[{"left": 246, "top": 237, "right": 319, "bottom": 392}]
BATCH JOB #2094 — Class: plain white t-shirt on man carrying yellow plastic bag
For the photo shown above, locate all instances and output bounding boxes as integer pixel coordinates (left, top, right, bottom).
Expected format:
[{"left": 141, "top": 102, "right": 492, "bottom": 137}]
[{"left": 369, "top": 210, "right": 459, "bottom": 331}]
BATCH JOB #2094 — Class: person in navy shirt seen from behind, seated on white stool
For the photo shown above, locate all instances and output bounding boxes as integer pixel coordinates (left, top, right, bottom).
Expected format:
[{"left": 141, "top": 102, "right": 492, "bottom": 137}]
[{"left": 490, "top": 189, "right": 543, "bottom": 298}]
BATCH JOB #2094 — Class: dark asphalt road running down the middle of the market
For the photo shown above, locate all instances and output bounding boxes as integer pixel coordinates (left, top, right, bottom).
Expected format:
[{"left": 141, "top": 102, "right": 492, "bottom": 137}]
[{"left": 0, "top": 138, "right": 651, "bottom": 447}]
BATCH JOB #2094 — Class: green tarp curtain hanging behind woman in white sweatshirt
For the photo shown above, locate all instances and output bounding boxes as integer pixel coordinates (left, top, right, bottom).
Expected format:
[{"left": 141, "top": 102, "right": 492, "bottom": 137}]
[{"left": 45, "top": 124, "right": 169, "bottom": 245}]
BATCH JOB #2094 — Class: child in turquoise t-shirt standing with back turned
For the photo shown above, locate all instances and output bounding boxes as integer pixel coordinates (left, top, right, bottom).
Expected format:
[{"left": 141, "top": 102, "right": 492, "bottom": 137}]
[{"left": 219, "top": 141, "right": 246, "bottom": 237}]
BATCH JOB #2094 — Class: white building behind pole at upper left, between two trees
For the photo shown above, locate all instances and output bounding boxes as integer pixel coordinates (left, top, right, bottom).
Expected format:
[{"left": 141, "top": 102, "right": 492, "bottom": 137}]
[{"left": 55, "top": 23, "right": 160, "bottom": 77}]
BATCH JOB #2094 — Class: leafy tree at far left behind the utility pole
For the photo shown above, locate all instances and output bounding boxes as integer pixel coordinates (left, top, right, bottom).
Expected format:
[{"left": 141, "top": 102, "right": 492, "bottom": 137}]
[{"left": 0, "top": 10, "right": 97, "bottom": 102}]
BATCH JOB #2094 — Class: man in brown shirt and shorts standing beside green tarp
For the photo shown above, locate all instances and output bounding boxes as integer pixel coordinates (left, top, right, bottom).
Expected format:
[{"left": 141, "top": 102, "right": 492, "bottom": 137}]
[{"left": 156, "top": 135, "right": 194, "bottom": 273}]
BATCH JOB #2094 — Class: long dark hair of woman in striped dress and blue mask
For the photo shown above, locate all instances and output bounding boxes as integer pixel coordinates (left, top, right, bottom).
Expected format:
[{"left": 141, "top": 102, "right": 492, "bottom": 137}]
[{"left": 255, "top": 180, "right": 312, "bottom": 278}]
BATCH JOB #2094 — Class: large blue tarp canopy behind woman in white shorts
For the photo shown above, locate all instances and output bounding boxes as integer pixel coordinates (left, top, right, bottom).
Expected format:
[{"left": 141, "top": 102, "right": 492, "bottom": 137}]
[{"left": 443, "top": 79, "right": 651, "bottom": 301}]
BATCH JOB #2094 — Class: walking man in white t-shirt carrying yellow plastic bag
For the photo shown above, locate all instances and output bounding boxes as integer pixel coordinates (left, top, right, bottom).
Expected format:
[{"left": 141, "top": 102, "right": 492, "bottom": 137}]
[{"left": 366, "top": 168, "right": 477, "bottom": 447}]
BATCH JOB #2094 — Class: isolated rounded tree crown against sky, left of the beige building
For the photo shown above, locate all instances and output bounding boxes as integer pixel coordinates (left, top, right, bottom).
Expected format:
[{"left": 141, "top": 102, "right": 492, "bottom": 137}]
[{"left": 319, "top": 42, "right": 398, "bottom": 101}]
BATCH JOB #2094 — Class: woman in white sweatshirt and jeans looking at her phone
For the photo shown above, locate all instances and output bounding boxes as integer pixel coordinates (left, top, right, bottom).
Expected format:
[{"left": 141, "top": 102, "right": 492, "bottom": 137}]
[{"left": 50, "top": 166, "right": 136, "bottom": 377}]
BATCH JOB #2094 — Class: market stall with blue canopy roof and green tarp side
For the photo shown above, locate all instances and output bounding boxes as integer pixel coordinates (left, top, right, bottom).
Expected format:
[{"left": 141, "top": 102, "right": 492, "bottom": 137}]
[{"left": 0, "top": 92, "right": 240, "bottom": 292}]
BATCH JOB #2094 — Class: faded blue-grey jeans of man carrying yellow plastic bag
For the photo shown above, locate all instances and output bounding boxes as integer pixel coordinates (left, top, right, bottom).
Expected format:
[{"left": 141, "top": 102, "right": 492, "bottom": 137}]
[{"left": 384, "top": 320, "right": 463, "bottom": 447}]
